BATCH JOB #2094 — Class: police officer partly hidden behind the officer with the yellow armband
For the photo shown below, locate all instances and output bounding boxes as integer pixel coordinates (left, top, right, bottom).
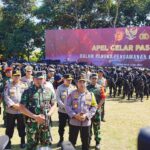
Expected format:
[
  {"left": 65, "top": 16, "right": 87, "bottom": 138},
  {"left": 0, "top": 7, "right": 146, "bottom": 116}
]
[{"left": 56, "top": 74, "right": 76, "bottom": 147}]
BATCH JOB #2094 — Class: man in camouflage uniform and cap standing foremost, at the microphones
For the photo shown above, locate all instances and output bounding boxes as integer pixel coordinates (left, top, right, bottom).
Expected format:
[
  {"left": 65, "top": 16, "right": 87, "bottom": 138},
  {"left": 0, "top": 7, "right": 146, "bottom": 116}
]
[{"left": 14, "top": 72, "right": 56, "bottom": 150}]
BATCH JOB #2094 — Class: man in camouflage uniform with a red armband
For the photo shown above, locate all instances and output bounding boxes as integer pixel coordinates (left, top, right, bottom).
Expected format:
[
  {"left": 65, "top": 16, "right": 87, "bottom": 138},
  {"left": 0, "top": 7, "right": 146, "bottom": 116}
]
[{"left": 87, "top": 73, "right": 105, "bottom": 150}]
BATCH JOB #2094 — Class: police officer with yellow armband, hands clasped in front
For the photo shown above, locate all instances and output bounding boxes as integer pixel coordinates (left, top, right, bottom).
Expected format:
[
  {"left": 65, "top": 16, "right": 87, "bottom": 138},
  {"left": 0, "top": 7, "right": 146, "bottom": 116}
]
[{"left": 66, "top": 77, "right": 97, "bottom": 150}]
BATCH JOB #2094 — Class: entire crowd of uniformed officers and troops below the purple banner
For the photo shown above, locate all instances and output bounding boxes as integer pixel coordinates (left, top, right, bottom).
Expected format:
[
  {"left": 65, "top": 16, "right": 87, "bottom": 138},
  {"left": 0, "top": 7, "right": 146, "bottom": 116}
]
[{"left": 0, "top": 63, "right": 150, "bottom": 150}]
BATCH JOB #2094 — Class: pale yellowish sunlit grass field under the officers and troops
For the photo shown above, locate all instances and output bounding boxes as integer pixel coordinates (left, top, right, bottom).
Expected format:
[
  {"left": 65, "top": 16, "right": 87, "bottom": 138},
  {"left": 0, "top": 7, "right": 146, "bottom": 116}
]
[{"left": 0, "top": 95, "right": 150, "bottom": 150}]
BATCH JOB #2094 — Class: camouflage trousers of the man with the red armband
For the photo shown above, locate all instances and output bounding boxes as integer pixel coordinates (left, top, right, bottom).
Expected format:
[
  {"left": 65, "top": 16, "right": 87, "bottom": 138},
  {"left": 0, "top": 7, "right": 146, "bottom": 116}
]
[{"left": 91, "top": 110, "right": 101, "bottom": 144}]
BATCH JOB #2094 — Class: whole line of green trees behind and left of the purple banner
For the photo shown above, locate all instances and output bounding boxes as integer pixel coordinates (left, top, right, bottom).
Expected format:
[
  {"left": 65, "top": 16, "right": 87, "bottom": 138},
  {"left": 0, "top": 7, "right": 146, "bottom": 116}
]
[{"left": 0, "top": 0, "right": 150, "bottom": 59}]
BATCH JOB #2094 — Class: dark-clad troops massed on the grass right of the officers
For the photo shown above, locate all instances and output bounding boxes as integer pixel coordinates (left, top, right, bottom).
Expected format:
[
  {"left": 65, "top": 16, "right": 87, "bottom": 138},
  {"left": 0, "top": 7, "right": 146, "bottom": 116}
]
[{"left": 107, "top": 67, "right": 150, "bottom": 102}]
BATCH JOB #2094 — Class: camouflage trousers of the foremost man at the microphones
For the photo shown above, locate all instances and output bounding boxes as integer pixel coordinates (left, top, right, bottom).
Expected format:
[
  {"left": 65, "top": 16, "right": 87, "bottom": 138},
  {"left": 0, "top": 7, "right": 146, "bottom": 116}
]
[{"left": 26, "top": 122, "right": 51, "bottom": 150}]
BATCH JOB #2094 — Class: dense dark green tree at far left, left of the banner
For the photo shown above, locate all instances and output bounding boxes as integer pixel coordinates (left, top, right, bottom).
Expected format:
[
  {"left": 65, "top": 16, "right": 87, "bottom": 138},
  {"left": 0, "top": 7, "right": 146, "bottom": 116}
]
[{"left": 0, "top": 0, "right": 35, "bottom": 58}]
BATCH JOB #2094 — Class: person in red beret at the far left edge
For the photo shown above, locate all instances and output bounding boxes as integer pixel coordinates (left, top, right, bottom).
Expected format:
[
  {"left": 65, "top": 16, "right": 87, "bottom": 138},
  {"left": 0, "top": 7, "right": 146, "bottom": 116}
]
[{"left": 0, "top": 67, "right": 12, "bottom": 127}]
